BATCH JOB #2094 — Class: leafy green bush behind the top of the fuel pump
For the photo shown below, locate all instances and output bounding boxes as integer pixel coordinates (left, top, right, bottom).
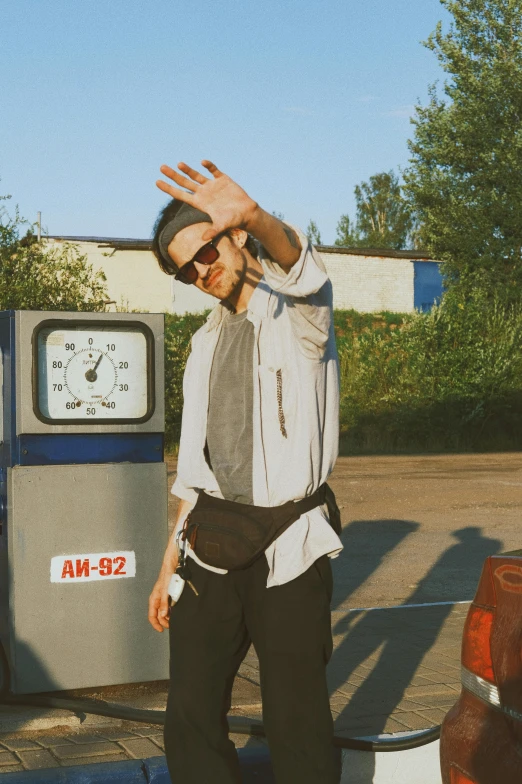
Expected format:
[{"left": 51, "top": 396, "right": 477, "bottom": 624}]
[{"left": 0, "top": 196, "right": 108, "bottom": 311}]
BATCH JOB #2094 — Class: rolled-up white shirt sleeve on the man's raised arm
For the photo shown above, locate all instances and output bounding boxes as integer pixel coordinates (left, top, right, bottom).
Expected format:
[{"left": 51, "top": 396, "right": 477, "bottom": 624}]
[{"left": 259, "top": 224, "right": 328, "bottom": 297}]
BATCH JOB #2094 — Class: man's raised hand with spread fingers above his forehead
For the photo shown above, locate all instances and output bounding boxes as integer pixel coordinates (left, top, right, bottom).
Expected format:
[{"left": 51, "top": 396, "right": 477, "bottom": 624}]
[{"left": 156, "top": 160, "right": 258, "bottom": 242}]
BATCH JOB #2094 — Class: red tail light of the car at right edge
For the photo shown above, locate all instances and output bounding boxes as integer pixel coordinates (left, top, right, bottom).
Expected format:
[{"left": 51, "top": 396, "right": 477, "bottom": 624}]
[{"left": 462, "top": 558, "right": 497, "bottom": 683}]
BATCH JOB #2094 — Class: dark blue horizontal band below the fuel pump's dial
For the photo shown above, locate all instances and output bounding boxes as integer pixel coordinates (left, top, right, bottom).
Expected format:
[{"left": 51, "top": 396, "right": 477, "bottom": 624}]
[{"left": 13, "top": 433, "right": 163, "bottom": 466}]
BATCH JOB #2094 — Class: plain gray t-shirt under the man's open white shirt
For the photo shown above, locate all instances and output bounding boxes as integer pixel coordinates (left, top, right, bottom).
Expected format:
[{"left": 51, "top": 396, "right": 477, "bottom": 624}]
[{"left": 207, "top": 311, "right": 254, "bottom": 504}]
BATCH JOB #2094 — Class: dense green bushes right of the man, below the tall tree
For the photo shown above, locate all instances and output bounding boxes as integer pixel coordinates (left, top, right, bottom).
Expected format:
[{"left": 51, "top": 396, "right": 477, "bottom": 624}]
[{"left": 339, "top": 288, "right": 522, "bottom": 452}]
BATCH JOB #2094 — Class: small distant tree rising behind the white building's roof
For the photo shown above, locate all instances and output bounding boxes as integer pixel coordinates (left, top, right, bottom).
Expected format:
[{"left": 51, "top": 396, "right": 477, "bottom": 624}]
[{"left": 335, "top": 171, "right": 413, "bottom": 250}]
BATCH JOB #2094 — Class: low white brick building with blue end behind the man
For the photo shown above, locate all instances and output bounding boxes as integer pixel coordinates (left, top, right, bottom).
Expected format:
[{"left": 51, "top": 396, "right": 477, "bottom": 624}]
[{"left": 47, "top": 237, "right": 442, "bottom": 315}]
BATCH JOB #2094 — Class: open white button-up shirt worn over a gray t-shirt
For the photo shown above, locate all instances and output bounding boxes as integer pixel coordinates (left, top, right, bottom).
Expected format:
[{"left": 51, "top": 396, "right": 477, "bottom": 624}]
[{"left": 172, "top": 224, "right": 342, "bottom": 587}]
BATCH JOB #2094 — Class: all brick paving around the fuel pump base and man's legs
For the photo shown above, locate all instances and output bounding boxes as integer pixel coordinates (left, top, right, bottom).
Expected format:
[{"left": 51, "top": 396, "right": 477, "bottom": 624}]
[{"left": 0, "top": 604, "right": 468, "bottom": 776}]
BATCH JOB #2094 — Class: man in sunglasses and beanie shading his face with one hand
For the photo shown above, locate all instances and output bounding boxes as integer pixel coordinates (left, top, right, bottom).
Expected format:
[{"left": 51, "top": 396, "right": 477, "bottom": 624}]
[{"left": 149, "top": 160, "right": 342, "bottom": 784}]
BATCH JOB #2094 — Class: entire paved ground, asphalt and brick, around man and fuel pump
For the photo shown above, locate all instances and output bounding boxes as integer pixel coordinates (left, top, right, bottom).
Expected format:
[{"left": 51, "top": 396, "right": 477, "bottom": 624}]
[{"left": 0, "top": 454, "right": 522, "bottom": 782}]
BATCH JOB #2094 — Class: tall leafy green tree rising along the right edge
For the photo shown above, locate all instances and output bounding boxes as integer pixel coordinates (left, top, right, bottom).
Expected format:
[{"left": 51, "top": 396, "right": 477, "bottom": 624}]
[{"left": 405, "top": 0, "right": 522, "bottom": 301}]
